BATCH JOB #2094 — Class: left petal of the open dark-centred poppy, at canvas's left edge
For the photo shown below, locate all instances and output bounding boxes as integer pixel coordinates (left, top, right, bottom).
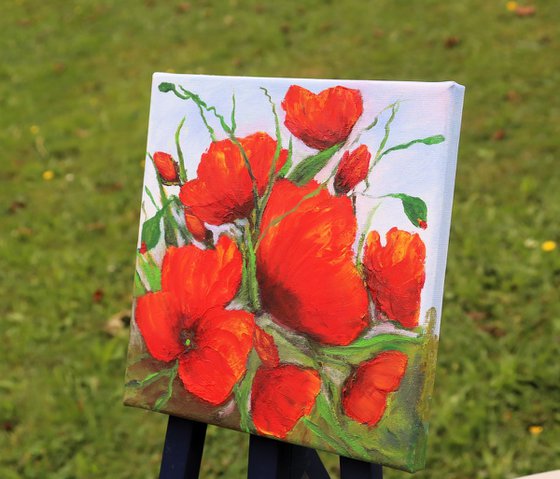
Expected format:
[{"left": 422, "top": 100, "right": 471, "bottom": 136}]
[{"left": 134, "top": 291, "right": 184, "bottom": 362}]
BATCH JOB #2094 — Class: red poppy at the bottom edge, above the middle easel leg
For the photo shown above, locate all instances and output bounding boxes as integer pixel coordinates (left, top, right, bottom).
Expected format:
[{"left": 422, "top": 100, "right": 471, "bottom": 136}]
[{"left": 251, "top": 364, "right": 321, "bottom": 439}]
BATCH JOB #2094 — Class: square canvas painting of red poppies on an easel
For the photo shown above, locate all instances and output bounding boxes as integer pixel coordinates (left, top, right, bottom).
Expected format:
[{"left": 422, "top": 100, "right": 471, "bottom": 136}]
[{"left": 125, "top": 73, "right": 463, "bottom": 471}]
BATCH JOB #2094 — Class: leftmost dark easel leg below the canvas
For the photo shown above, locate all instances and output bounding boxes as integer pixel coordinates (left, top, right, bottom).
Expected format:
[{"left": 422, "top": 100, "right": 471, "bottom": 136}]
[{"left": 159, "top": 416, "right": 206, "bottom": 479}]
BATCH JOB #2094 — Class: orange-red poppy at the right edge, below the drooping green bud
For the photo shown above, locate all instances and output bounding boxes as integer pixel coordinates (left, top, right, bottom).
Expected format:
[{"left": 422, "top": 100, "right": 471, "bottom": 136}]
[{"left": 363, "top": 227, "right": 426, "bottom": 328}]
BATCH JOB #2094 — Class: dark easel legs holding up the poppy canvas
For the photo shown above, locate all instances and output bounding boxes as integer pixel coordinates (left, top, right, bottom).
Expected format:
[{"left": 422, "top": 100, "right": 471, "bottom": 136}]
[{"left": 159, "top": 416, "right": 383, "bottom": 479}]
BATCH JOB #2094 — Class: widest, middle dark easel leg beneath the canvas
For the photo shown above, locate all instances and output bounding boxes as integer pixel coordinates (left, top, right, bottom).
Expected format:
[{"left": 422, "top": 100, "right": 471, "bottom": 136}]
[{"left": 247, "top": 435, "right": 329, "bottom": 479}]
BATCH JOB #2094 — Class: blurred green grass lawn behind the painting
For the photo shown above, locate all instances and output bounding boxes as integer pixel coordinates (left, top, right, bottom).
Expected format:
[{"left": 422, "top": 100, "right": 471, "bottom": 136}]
[{"left": 0, "top": 0, "right": 560, "bottom": 479}]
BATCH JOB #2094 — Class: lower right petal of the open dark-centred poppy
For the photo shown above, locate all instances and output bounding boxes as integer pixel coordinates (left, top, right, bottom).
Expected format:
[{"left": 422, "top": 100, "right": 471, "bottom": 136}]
[{"left": 179, "top": 308, "right": 255, "bottom": 405}]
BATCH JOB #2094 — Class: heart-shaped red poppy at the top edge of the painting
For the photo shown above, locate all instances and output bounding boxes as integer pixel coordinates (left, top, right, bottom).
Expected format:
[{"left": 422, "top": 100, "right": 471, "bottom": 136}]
[{"left": 282, "top": 85, "right": 364, "bottom": 150}]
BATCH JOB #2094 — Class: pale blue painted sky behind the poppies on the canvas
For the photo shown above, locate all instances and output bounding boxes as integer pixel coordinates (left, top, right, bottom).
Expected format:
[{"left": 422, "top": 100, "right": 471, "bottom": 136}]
[{"left": 142, "top": 73, "right": 464, "bottom": 329}]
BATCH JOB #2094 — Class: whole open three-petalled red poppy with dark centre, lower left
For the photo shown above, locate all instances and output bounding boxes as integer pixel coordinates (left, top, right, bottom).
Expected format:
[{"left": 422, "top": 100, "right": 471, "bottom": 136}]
[{"left": 135, "top": 236, "right": 255, "bottom": 405}]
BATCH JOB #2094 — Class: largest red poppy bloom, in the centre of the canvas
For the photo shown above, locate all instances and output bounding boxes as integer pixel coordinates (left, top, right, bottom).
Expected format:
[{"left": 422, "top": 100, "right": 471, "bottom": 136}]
[{"left": 257, "top": 180, "right": 368, "bottom": 345}]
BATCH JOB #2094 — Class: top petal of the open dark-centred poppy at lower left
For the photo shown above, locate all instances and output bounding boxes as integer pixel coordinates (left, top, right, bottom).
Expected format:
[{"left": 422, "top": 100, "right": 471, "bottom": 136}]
[{"left": 161, "top": 235, "right": 242, "bottom": 327}]
